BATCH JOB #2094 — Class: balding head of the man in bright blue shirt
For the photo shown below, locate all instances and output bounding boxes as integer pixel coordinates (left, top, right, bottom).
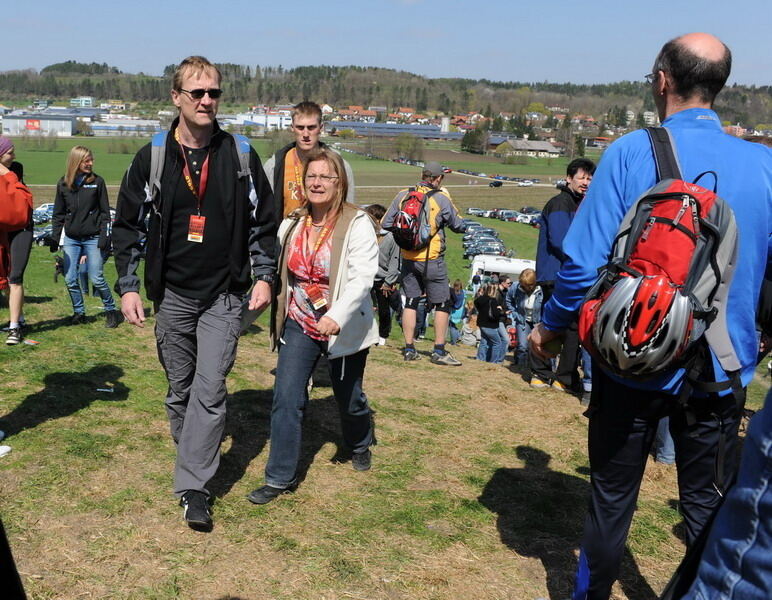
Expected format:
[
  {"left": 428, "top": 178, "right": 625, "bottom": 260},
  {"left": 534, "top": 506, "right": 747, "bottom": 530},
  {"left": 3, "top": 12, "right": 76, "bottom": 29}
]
[{"left": 654, "top": 33, "right": 732, "bottom": 106}]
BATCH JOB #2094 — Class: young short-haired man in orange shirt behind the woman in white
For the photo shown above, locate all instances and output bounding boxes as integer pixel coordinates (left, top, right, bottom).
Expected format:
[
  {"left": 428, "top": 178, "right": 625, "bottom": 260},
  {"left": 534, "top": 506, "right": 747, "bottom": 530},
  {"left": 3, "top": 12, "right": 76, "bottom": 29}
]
[{"left": 265, "top": 101, "right": 354, "bottom": 223}]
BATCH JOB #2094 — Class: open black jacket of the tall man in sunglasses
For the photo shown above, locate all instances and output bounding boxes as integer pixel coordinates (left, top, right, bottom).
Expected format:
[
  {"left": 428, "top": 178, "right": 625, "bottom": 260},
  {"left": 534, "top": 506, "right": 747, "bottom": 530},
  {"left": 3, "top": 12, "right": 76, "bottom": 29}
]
[{"left": 112, "top": 119, "right": 277, "bottom": 301}]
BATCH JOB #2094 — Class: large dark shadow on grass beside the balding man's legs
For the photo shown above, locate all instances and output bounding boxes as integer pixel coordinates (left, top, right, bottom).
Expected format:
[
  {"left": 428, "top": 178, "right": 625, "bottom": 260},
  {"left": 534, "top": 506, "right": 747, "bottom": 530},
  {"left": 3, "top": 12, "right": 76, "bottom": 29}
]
[{"left": 479, "top": 446, "right": 657, "bottom": 600}]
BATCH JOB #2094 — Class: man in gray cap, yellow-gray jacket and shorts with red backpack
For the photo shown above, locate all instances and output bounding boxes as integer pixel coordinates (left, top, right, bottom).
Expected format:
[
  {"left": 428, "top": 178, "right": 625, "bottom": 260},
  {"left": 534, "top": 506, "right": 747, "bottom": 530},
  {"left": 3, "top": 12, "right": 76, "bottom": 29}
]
[{"left": 383, "top": 162, "right": 466, "bottom": 366}]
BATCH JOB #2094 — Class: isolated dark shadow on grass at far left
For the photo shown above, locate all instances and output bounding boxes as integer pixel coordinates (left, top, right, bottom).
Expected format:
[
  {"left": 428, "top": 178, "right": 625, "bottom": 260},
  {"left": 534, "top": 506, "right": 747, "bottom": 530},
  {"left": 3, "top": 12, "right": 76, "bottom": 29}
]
[{"left": 0, "top": 364, "right": 129, "bottom": 436}]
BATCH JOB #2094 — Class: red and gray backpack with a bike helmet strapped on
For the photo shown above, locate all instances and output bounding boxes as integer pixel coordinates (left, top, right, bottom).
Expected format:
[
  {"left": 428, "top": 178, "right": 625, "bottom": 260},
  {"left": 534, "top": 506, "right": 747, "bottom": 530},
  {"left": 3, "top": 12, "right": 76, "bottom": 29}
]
[{"left": 579, "top": 127, "right": 740, "bottom": 391}]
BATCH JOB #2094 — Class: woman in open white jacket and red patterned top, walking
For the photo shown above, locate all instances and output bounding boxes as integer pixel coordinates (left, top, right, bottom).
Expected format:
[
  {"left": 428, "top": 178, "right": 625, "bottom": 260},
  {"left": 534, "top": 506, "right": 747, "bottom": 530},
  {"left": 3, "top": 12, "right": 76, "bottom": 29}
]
[{"left": 248, "top": 148, "right": 378, "bottom": 504}]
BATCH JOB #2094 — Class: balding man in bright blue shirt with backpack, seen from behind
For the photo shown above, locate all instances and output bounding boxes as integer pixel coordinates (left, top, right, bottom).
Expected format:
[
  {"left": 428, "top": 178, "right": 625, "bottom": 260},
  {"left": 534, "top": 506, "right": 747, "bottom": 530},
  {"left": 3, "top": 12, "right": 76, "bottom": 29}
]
[{"left": 529, "top": 33, "right": 772, "bottom": 600}]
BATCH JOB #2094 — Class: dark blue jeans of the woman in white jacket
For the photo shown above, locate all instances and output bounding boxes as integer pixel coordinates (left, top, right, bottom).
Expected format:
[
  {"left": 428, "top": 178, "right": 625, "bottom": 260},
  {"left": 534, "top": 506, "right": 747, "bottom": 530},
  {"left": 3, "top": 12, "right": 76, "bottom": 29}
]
[{"left": 265, "top": 319, "right": 375, "bottom": 489}]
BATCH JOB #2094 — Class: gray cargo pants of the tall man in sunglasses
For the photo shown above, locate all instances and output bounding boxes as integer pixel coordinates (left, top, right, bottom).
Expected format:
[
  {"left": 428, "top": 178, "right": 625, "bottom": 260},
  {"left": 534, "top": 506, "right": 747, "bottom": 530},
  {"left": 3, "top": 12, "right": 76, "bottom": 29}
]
[{"left": 155, "top": 288, "right": 242, "bottom": 496}]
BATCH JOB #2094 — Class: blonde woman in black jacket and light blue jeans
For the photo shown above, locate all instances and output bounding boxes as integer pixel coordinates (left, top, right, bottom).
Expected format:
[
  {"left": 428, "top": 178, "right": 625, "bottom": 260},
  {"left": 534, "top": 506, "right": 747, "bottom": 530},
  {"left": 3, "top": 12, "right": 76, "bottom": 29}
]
[{"left": 52, "top": 146, "right": 120, "bottom": 328}]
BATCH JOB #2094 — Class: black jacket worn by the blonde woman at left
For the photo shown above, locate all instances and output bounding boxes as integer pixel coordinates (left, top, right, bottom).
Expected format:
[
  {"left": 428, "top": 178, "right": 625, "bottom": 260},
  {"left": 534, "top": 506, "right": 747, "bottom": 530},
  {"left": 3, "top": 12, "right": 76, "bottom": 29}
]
[{"left": 51, "top": 174, "right": 110, "bottom": 248}]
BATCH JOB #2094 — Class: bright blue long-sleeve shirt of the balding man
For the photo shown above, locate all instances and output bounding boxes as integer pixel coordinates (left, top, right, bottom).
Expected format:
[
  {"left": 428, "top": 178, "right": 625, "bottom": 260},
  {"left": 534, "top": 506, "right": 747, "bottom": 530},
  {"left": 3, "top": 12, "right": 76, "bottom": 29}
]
[{"left": 542, "top": 108, "right": 772, "bottom": 393}]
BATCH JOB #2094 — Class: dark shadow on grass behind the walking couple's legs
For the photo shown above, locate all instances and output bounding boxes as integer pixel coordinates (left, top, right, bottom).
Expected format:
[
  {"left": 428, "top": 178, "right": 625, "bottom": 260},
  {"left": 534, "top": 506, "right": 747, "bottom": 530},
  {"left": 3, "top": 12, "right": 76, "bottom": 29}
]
[{"left": 207, "top": 384, "right": 344, "bottom": 498}]
